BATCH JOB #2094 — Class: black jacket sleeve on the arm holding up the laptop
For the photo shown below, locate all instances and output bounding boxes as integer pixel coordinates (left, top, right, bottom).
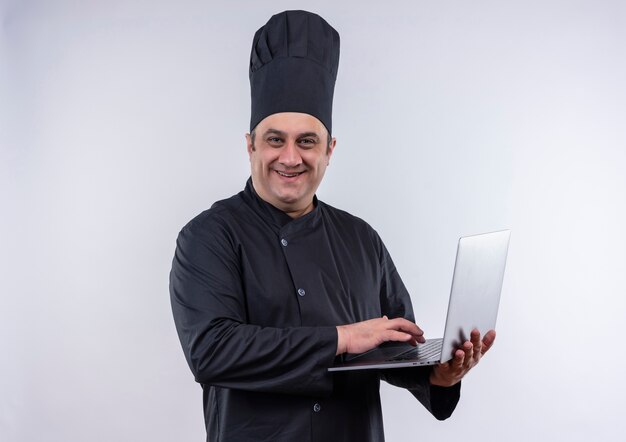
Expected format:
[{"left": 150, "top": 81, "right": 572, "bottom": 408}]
[{"left": 376, "top": 230, "right": 461, "bottom": 420}]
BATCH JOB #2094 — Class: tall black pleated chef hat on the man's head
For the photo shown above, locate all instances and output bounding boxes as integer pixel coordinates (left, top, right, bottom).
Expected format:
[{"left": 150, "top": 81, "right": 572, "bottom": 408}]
[{"left": 250, "top": 11, "right": 339, "bottom": 133}]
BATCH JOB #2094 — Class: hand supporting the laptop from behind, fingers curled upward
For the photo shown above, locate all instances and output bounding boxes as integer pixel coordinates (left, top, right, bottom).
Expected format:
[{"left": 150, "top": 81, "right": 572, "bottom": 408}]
[{"left": 430, "top": 329, "right": 496, "bottom": 387}]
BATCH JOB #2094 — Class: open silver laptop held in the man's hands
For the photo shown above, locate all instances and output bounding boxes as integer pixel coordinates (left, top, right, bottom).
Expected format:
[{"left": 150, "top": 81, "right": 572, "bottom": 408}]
[{"left": 328, "top": 230, "right": 511, "bottom": 371}]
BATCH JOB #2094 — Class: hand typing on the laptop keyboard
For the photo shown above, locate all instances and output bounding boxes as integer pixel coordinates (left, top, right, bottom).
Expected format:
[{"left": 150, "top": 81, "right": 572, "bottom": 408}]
[{"left": 337, "top": 316, "right": 426, "bottom": 355}]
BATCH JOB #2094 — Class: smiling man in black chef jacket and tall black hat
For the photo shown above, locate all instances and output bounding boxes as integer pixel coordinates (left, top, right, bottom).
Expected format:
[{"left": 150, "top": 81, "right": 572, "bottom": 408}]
[{"left": 170, "top": 11, "right": 495, "bottom": 442}]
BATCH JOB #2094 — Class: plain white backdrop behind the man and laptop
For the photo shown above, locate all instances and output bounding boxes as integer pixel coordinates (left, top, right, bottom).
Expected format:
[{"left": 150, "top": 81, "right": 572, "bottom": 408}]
[{"left": 0, "top": 0, "right": 626, "bottom": 442}]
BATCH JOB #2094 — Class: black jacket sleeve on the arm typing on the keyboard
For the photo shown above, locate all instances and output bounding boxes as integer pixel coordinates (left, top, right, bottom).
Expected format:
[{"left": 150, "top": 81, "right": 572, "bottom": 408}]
[{"left": 170, "top": 217, "right": 337, "bottom": 395}]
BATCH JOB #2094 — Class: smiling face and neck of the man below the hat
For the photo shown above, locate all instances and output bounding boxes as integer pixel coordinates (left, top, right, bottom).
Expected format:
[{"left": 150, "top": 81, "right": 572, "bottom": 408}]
[{"left": 246, "top": 112, "right": 336, "bottom": 218}]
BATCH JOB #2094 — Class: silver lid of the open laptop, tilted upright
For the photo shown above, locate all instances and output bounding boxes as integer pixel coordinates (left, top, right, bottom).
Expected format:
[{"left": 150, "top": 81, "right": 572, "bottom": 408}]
[{"left": 441, "top": 230, "right": 511, "bottom": 362}]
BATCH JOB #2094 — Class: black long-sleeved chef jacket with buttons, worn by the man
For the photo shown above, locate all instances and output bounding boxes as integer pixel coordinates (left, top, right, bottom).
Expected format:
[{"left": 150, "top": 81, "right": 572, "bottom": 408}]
[{"left": 170, "top": 180, "right": 460, "bottom": 442}]
